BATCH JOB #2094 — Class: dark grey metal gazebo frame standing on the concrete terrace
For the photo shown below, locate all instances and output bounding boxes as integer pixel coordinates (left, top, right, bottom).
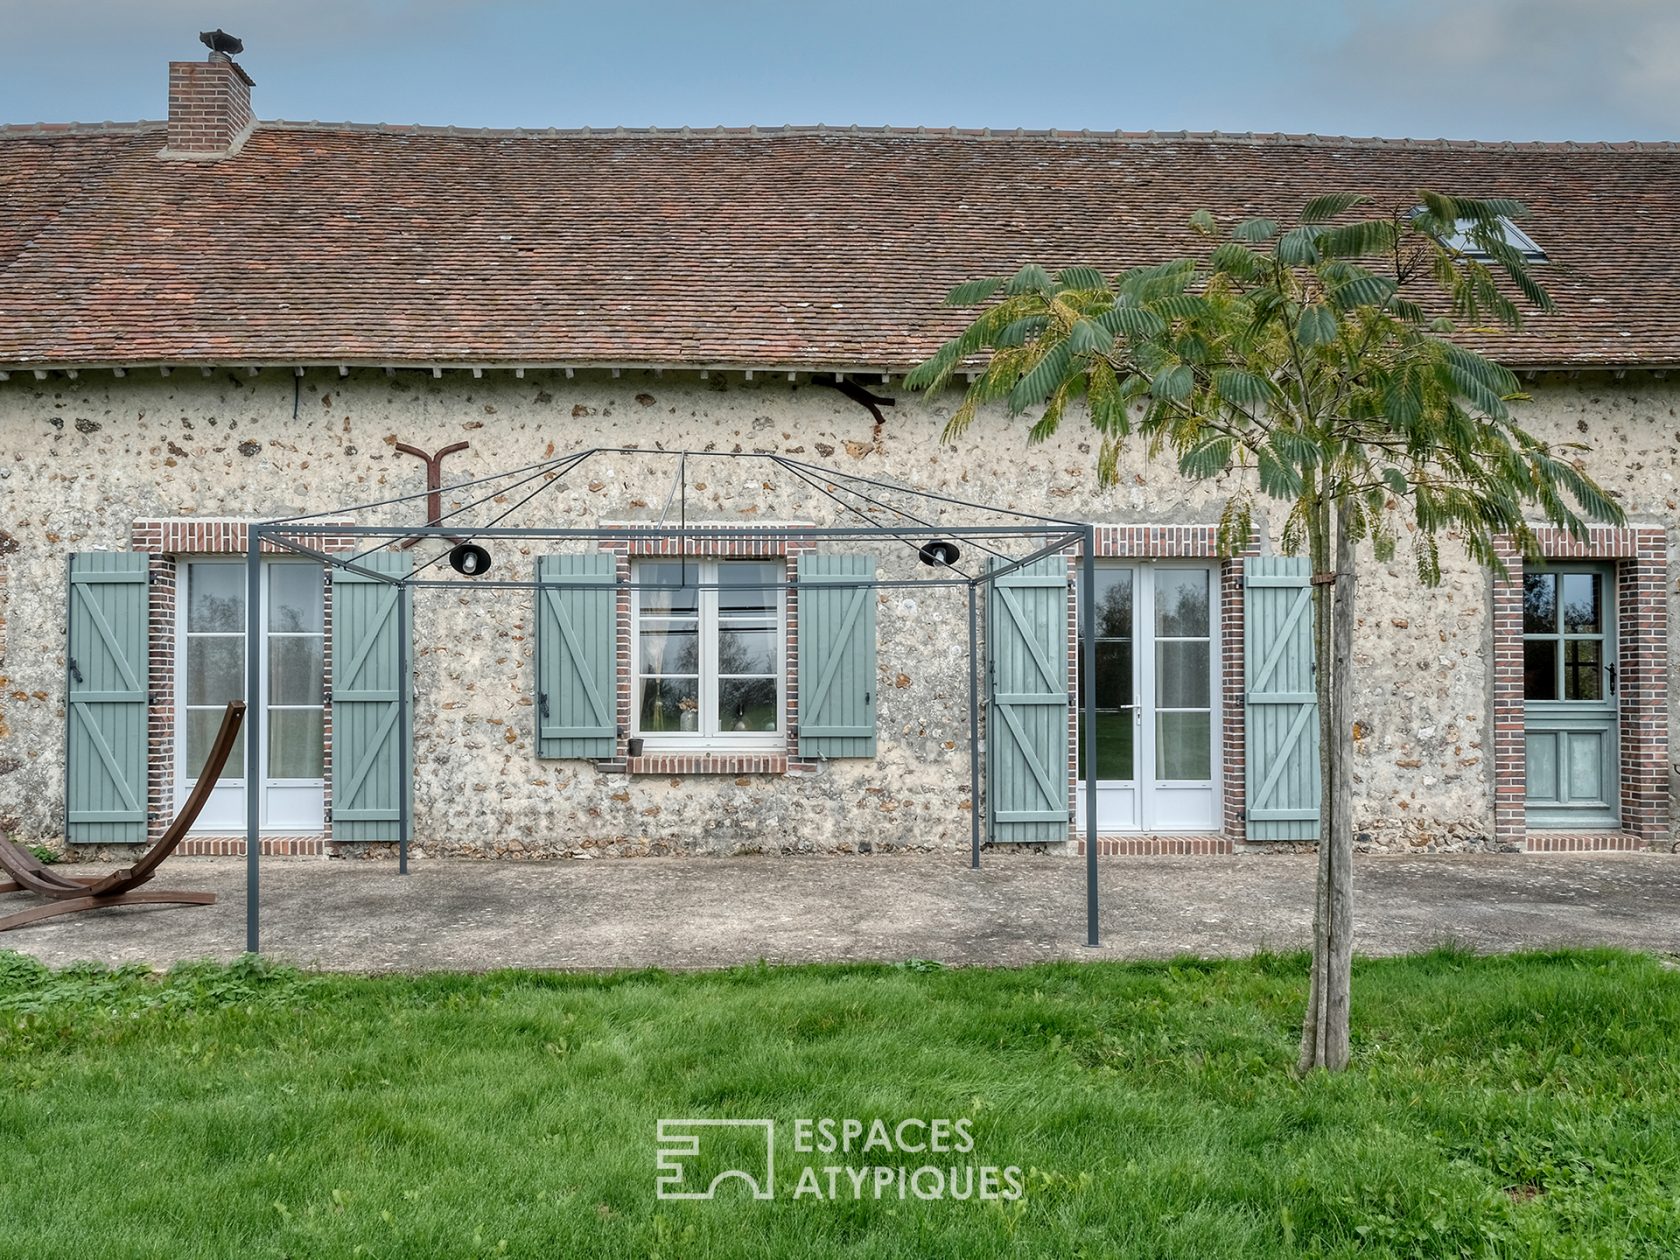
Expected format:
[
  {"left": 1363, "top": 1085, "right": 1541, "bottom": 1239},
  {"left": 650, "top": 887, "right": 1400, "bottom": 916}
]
[{"left": 245, "top": 447, "right": 1099, "bottom": 953}]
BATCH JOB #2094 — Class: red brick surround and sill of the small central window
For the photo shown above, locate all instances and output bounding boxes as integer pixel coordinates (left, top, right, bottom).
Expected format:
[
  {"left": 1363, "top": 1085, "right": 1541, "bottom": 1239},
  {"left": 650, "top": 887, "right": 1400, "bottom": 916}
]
[{"left": 596, "top": 526, "right": 816, "bottom": 774}]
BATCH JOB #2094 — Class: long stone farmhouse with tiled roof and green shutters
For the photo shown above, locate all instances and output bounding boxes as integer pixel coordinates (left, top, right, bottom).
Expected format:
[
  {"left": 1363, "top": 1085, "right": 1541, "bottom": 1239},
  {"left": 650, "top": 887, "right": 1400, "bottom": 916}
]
[{"left": 0, "top": 42, "right": 1680, "bottom": 857}]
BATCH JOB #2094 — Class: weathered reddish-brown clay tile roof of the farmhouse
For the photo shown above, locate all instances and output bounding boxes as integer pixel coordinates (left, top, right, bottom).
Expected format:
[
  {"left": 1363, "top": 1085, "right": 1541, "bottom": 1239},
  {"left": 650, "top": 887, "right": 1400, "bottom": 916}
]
[{"left": 0, "top": 123, "right": 1680, "bottom": 370}]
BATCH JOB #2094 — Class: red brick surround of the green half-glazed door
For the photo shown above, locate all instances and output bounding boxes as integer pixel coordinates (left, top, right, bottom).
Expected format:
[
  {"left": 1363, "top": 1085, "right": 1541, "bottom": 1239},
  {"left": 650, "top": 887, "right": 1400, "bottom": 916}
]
[{"left": 1494, "top": 526, "right": 1668, "bottom": 850}]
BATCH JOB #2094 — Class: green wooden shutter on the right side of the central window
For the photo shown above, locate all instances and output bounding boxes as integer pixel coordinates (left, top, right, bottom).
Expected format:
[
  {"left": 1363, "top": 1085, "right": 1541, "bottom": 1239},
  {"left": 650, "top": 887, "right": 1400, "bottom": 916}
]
[{"left": 798, "top": 553, "right": 875, "bottom": 758}]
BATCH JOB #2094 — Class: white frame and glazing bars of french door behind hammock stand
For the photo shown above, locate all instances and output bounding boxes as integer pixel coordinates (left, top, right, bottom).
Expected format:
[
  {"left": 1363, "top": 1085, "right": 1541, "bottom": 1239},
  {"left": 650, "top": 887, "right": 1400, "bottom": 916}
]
[{"left": 173, "top": 554, "right": 331, "bottom": 833}]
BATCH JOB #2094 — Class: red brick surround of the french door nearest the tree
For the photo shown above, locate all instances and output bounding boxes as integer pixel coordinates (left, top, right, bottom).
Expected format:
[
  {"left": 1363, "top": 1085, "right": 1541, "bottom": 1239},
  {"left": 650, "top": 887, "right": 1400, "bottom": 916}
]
[{"left": 1067, "top": 524, "right": 1260, "bottom": 852}]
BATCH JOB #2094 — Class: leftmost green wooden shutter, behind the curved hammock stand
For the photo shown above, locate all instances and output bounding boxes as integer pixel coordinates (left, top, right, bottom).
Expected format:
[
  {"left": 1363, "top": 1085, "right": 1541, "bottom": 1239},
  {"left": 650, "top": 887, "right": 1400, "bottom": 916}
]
[{"left": 64, "top": 551, "right": 150, "bottom": 845}]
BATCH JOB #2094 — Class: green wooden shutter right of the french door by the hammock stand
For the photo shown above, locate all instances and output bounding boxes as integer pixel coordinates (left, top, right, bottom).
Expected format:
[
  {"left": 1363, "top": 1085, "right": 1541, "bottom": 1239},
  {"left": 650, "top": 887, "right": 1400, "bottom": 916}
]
[{"left": 333, "top": 551, "right": 413, "bottom": 840}]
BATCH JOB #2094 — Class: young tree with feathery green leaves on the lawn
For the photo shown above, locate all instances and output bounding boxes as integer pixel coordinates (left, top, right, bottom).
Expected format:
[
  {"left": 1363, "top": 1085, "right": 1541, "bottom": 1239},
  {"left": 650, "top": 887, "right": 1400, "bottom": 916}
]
[{"left": 907, "top": 192, "right": 1623, "bottom": 1072}]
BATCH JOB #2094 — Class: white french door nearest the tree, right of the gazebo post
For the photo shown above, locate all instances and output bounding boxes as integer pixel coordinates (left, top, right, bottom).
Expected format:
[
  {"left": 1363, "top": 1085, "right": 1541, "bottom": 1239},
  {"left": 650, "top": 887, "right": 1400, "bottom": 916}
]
[{"left": 1077, "top": 561, "right": 1220, "bottom": 832}]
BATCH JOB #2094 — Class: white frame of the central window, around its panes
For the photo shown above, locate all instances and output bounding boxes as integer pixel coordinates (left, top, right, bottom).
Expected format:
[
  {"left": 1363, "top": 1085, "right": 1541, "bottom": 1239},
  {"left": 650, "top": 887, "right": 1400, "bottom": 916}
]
[{"left": 630, "top": 556, "right": 788, "bottom": 753}]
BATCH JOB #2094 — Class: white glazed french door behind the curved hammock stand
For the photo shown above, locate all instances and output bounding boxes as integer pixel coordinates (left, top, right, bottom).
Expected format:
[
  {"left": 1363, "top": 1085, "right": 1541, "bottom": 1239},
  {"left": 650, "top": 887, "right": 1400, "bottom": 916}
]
[{"left": 175, "top": 559, "right": 326, "bottom": 835}]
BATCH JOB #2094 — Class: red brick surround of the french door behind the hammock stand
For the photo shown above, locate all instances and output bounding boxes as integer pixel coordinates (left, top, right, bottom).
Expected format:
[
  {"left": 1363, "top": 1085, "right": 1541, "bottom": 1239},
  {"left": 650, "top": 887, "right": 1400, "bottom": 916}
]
[{"left": 129, "top": 516, "right": 356, "bottom": 855}]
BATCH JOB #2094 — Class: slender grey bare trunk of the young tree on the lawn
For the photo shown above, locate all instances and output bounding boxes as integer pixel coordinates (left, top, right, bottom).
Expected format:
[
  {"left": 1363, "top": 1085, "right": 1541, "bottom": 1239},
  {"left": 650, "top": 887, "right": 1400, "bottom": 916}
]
[{"left": 1300, "top": 504, "right": 1354, "bottom": 1072}]
